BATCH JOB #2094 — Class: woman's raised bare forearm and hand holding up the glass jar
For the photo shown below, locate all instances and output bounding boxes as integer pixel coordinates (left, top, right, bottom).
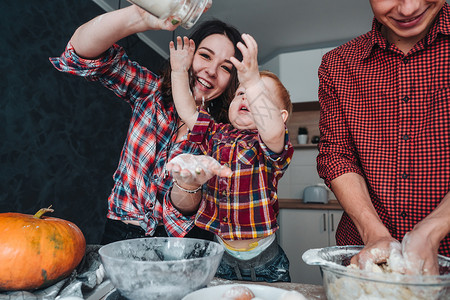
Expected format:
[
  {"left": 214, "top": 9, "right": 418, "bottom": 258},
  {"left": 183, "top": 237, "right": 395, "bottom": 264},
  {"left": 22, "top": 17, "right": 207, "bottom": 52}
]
[{"left": 70, "top": 5, "right": 177, "bottom": 59}]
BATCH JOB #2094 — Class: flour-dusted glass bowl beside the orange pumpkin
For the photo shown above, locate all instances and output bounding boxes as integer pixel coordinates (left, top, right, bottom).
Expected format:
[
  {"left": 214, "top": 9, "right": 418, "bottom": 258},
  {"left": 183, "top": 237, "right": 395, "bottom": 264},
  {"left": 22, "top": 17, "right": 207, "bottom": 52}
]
[{"left": 99, "top": 237, "right": 224, "bottom": 300}]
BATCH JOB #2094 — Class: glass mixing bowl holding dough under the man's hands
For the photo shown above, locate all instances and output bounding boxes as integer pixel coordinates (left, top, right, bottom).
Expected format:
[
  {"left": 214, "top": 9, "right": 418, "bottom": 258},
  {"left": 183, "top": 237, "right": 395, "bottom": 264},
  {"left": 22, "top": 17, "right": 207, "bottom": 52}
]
[{"left": 302, "top": 246, "right": 450, "bottom": 300}]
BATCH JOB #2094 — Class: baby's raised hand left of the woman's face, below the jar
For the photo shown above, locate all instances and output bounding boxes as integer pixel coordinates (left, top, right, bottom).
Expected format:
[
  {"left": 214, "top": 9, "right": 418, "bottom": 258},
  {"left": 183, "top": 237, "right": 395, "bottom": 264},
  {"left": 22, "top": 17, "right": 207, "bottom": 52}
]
[{"left": 169, "top": 36, "right": 195, "bottom": 72}]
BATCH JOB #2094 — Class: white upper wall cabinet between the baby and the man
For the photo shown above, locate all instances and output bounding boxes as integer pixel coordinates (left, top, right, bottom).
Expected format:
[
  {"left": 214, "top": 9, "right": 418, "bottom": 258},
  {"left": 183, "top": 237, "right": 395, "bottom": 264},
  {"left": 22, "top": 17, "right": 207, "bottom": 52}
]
[{"left": 261, "top": 47, "right": 333, "bottom": 102}]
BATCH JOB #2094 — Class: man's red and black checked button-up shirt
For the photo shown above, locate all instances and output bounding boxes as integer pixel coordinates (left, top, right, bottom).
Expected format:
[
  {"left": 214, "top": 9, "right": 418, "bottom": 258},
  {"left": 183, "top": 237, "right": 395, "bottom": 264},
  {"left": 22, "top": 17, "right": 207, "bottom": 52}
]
[{"left": 317, "top": 3, "right": 450, "bottom": 256}]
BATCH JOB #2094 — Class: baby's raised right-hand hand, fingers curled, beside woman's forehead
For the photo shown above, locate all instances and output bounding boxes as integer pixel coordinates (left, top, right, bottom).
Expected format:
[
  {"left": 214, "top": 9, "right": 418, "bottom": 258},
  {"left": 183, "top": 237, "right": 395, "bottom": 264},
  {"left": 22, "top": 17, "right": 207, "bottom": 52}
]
[{"left": 230, "top": 33, "right": 260, "bottom": 88}]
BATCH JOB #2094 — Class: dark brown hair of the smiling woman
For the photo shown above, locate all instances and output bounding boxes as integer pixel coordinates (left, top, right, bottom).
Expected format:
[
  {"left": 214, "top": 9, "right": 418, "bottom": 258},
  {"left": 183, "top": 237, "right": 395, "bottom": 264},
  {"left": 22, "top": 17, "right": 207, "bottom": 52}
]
[{"left": 161, "top": 19, "right": 243, "bottom": 123}]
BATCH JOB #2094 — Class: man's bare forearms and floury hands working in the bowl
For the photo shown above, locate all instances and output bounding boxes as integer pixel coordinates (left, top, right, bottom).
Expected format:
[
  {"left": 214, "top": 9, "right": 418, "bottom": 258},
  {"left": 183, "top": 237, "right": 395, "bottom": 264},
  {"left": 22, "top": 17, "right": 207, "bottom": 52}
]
[{"left": 331, "top": 173, "right": 450, "bottom": 275}]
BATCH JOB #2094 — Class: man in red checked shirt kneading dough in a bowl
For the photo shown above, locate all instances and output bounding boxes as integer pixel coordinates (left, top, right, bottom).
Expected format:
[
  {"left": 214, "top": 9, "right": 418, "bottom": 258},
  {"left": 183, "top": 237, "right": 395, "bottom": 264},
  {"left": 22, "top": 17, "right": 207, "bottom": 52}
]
[{"left": 317, "top": 0, "right": 450, "bottom": 274}]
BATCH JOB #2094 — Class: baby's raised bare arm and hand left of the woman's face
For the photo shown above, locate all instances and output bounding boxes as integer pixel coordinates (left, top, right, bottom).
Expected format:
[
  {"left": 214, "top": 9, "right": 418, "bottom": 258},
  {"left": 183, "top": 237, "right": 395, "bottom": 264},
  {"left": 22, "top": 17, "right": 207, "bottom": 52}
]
[{"left": 169, "top": 37, "right": 198, "bottom": 130}]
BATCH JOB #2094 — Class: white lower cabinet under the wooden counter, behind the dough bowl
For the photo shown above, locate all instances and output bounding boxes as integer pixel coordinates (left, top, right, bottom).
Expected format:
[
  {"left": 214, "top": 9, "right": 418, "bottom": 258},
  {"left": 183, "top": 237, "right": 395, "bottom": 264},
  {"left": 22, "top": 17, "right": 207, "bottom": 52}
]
[{"left": 278, "top": 209, "right": 343, "bottom": 285}]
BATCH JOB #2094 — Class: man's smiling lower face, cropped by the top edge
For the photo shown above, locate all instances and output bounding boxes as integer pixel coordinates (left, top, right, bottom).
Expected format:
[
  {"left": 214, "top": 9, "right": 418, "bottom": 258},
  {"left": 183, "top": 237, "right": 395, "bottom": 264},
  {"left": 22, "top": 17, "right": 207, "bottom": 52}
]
[{"left": 370, "top": 0, "right": 445, "bottom": 44}]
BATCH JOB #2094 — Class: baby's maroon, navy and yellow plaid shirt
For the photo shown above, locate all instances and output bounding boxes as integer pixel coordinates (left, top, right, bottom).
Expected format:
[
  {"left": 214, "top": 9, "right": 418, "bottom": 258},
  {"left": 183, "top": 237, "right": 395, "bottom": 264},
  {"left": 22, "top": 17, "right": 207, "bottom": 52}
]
[{"left": 189, "top": 110, "right": 294, "bottom": 240}]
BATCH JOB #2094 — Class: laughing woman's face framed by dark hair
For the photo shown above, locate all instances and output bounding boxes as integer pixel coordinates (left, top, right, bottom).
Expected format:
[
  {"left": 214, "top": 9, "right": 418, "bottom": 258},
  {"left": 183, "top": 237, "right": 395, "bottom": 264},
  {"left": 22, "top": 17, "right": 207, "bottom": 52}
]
[{"left": 192, "top": 34, "right": 234, "bottom": 103}]
